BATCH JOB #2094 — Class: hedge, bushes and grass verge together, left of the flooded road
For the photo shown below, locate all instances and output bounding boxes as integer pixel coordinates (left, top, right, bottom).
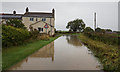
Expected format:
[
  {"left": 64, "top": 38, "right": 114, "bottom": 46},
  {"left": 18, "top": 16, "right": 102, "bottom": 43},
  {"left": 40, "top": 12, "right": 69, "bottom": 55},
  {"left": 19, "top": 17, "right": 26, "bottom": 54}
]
[{"left": 2, "top": 19, "right": 59, "bottom": 70}]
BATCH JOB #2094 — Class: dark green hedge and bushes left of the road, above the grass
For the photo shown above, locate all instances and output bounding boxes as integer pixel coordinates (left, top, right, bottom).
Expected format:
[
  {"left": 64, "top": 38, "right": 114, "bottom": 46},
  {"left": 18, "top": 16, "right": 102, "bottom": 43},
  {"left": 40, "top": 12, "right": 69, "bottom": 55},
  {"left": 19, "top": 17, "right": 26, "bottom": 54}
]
[{"left": 2, "top": 19, "right": 49, "bottom": 48}]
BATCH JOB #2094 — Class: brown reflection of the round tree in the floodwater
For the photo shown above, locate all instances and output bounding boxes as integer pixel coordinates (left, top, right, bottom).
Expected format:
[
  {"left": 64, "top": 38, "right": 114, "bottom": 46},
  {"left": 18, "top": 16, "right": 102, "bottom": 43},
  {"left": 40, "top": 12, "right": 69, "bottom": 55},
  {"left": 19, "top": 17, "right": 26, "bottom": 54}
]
[{"left": 66, "top": 35, "right": 82, "bottom": 46}]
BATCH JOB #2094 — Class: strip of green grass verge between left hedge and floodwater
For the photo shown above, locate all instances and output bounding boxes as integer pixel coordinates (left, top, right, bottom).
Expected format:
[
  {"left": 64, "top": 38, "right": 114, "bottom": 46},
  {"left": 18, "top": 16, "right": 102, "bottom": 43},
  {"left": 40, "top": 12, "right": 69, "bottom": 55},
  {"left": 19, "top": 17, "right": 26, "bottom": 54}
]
[{"left": 2, "top": 36, "right": 59, "bottom": 70}]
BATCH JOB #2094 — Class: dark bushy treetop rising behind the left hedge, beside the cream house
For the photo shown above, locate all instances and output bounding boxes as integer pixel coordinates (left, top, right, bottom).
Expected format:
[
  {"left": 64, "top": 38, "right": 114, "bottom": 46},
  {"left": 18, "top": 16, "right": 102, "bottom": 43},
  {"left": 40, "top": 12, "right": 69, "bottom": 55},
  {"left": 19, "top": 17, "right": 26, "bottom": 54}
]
[{"left": 6, "top": 19, "right": 25, "bottom": 28}]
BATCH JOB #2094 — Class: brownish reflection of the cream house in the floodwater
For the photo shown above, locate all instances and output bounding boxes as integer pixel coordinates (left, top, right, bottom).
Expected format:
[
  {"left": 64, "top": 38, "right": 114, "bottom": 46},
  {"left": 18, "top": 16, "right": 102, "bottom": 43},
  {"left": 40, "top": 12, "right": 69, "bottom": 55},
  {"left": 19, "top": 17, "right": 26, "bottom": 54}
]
[{"left": 9, "top": 41, "right": 54, "bottom": 70}]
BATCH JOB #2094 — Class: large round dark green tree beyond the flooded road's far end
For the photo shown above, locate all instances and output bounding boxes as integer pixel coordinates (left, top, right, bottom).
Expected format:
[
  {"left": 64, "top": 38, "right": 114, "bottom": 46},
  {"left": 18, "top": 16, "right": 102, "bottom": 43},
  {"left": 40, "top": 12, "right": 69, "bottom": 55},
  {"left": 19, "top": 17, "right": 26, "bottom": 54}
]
[{"left": 66, "top": 19, "right": 85, "bottom": 32}]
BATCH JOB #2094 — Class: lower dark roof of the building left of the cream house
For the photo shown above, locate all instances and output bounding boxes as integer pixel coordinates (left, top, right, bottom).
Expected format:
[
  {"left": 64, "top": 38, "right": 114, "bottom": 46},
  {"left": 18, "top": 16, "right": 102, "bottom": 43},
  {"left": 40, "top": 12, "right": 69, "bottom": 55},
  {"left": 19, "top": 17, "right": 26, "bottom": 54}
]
[{"left": 0, "top": 13, "right": 23, "bottom": 19}]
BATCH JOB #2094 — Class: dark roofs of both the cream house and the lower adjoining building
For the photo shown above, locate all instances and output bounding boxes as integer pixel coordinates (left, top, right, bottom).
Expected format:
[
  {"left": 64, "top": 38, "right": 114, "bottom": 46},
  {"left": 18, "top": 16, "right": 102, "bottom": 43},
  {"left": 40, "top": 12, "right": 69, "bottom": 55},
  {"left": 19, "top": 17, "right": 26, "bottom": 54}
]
[{"left": 0, "top": 12, "right": 54, "bottom": 19}]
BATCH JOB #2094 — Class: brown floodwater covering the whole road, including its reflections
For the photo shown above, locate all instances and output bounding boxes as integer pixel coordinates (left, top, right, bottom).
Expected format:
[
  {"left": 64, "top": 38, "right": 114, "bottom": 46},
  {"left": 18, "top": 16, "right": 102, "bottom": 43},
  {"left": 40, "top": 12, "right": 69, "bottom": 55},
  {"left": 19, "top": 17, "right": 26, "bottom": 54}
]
[{"left": 9, "top": 35, "right": 100, "bottom": 70}]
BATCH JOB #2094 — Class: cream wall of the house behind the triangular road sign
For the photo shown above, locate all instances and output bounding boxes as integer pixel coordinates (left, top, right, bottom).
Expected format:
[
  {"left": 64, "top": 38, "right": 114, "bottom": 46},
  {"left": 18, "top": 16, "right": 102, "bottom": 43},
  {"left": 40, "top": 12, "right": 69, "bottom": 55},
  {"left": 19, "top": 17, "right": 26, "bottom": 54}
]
[{"left": 22, "top": 17, "right": 55, "bottom": 35}]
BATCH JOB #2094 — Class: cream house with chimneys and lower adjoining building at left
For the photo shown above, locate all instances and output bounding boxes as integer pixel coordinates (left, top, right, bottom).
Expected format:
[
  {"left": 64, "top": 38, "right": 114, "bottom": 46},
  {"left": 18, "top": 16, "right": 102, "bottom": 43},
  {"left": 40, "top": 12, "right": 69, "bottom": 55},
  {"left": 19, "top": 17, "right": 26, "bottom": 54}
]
[{"left": 0, "top": 7, "right": 55, "bottom": 36}]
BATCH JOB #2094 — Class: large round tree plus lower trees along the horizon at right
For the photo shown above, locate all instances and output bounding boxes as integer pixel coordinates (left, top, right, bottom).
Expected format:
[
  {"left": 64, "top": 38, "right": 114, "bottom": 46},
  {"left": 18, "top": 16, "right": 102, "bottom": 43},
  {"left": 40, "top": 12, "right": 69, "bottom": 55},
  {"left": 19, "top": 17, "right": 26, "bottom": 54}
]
[{"left": 66, "top": 19, "right": 115, "bottom": 33}]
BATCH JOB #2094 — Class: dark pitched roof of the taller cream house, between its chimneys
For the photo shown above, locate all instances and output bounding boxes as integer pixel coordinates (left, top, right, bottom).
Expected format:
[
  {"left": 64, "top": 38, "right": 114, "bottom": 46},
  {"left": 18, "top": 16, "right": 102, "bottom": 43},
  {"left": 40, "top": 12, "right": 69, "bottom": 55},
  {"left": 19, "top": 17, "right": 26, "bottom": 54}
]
[{"left": 24, "top": 12, "right": 53, "bottom": 18}]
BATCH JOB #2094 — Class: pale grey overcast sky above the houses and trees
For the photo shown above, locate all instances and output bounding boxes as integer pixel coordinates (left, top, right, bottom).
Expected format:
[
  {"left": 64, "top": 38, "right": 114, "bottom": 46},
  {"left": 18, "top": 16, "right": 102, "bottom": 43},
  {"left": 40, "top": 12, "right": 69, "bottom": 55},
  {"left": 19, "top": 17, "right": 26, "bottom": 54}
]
[{"left": 2, "top": 2, "right": 118, "bottom": 30}]
